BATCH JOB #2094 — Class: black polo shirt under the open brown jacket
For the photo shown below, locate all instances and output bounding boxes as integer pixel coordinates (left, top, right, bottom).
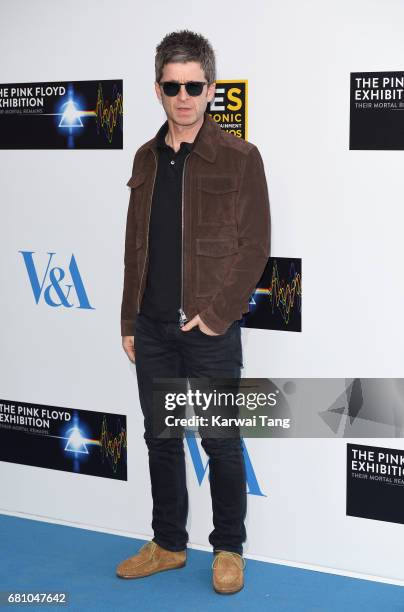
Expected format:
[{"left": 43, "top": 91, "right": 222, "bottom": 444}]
[{"left": 140, "top": 121, "right": 194, "bottom": 322}]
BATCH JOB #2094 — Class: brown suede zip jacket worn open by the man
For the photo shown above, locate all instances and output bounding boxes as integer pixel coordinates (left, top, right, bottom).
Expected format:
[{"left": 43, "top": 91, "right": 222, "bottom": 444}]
[{"left": 121, "top": 112, "right": 270, "bottom": 336}]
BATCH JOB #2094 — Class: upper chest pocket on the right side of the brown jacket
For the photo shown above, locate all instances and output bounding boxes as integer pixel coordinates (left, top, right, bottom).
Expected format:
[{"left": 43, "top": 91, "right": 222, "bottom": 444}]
[{"left": 198, "top": 176, "right": 238, "bottom": 226}]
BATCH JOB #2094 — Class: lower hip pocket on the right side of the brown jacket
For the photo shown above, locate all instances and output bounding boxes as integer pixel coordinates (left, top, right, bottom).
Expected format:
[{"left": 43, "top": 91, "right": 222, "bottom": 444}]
[{"left": 195, "top": 238, "right": 238, "bottom": 297}]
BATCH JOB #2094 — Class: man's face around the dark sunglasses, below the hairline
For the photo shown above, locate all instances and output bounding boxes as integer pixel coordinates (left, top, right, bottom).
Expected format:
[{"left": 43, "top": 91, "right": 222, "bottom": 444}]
[{"left": 154, "top": 62, "right": 215, "bottom": 126}]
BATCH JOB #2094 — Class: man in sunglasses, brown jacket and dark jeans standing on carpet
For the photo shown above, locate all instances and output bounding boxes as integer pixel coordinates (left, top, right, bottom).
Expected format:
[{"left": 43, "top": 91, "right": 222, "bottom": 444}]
[{"left": 117, "top": 30, "right": 270, "bottom": 593}]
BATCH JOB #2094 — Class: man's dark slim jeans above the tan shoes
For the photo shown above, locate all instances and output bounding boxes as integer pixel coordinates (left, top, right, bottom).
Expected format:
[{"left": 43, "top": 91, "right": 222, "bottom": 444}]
[{"left": 135, "top": 313, "right": 247, "bottom": 554}]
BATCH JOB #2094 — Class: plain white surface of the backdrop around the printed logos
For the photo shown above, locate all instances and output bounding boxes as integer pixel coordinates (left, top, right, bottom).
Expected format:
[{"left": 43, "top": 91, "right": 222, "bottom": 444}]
[{"left": 0, "top": 0, "right": 404, "bottom": 581}]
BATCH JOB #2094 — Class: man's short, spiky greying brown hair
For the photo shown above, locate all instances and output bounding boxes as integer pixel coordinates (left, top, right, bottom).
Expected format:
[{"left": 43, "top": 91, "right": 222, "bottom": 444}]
[{"left": 155, "top": 30, "right": 216, "bottom": 84}]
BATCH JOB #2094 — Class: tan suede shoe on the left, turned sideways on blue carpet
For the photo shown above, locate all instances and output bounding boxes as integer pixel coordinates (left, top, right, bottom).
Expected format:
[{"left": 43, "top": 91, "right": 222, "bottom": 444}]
[{"left": 116, "top": 541, "right": 187, "bottom": 578}]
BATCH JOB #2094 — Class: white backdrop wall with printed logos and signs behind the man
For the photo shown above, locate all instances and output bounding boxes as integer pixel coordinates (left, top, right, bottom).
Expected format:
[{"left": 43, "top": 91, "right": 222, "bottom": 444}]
[{"left": 0, "top": 0, "right": 404, "bottom": 581}]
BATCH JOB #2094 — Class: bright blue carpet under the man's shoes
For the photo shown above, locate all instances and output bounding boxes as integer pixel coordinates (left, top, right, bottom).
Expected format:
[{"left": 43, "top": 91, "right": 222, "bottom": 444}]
[{"left": 0, "top": 515, "right": 404, "bottom": 612}]
